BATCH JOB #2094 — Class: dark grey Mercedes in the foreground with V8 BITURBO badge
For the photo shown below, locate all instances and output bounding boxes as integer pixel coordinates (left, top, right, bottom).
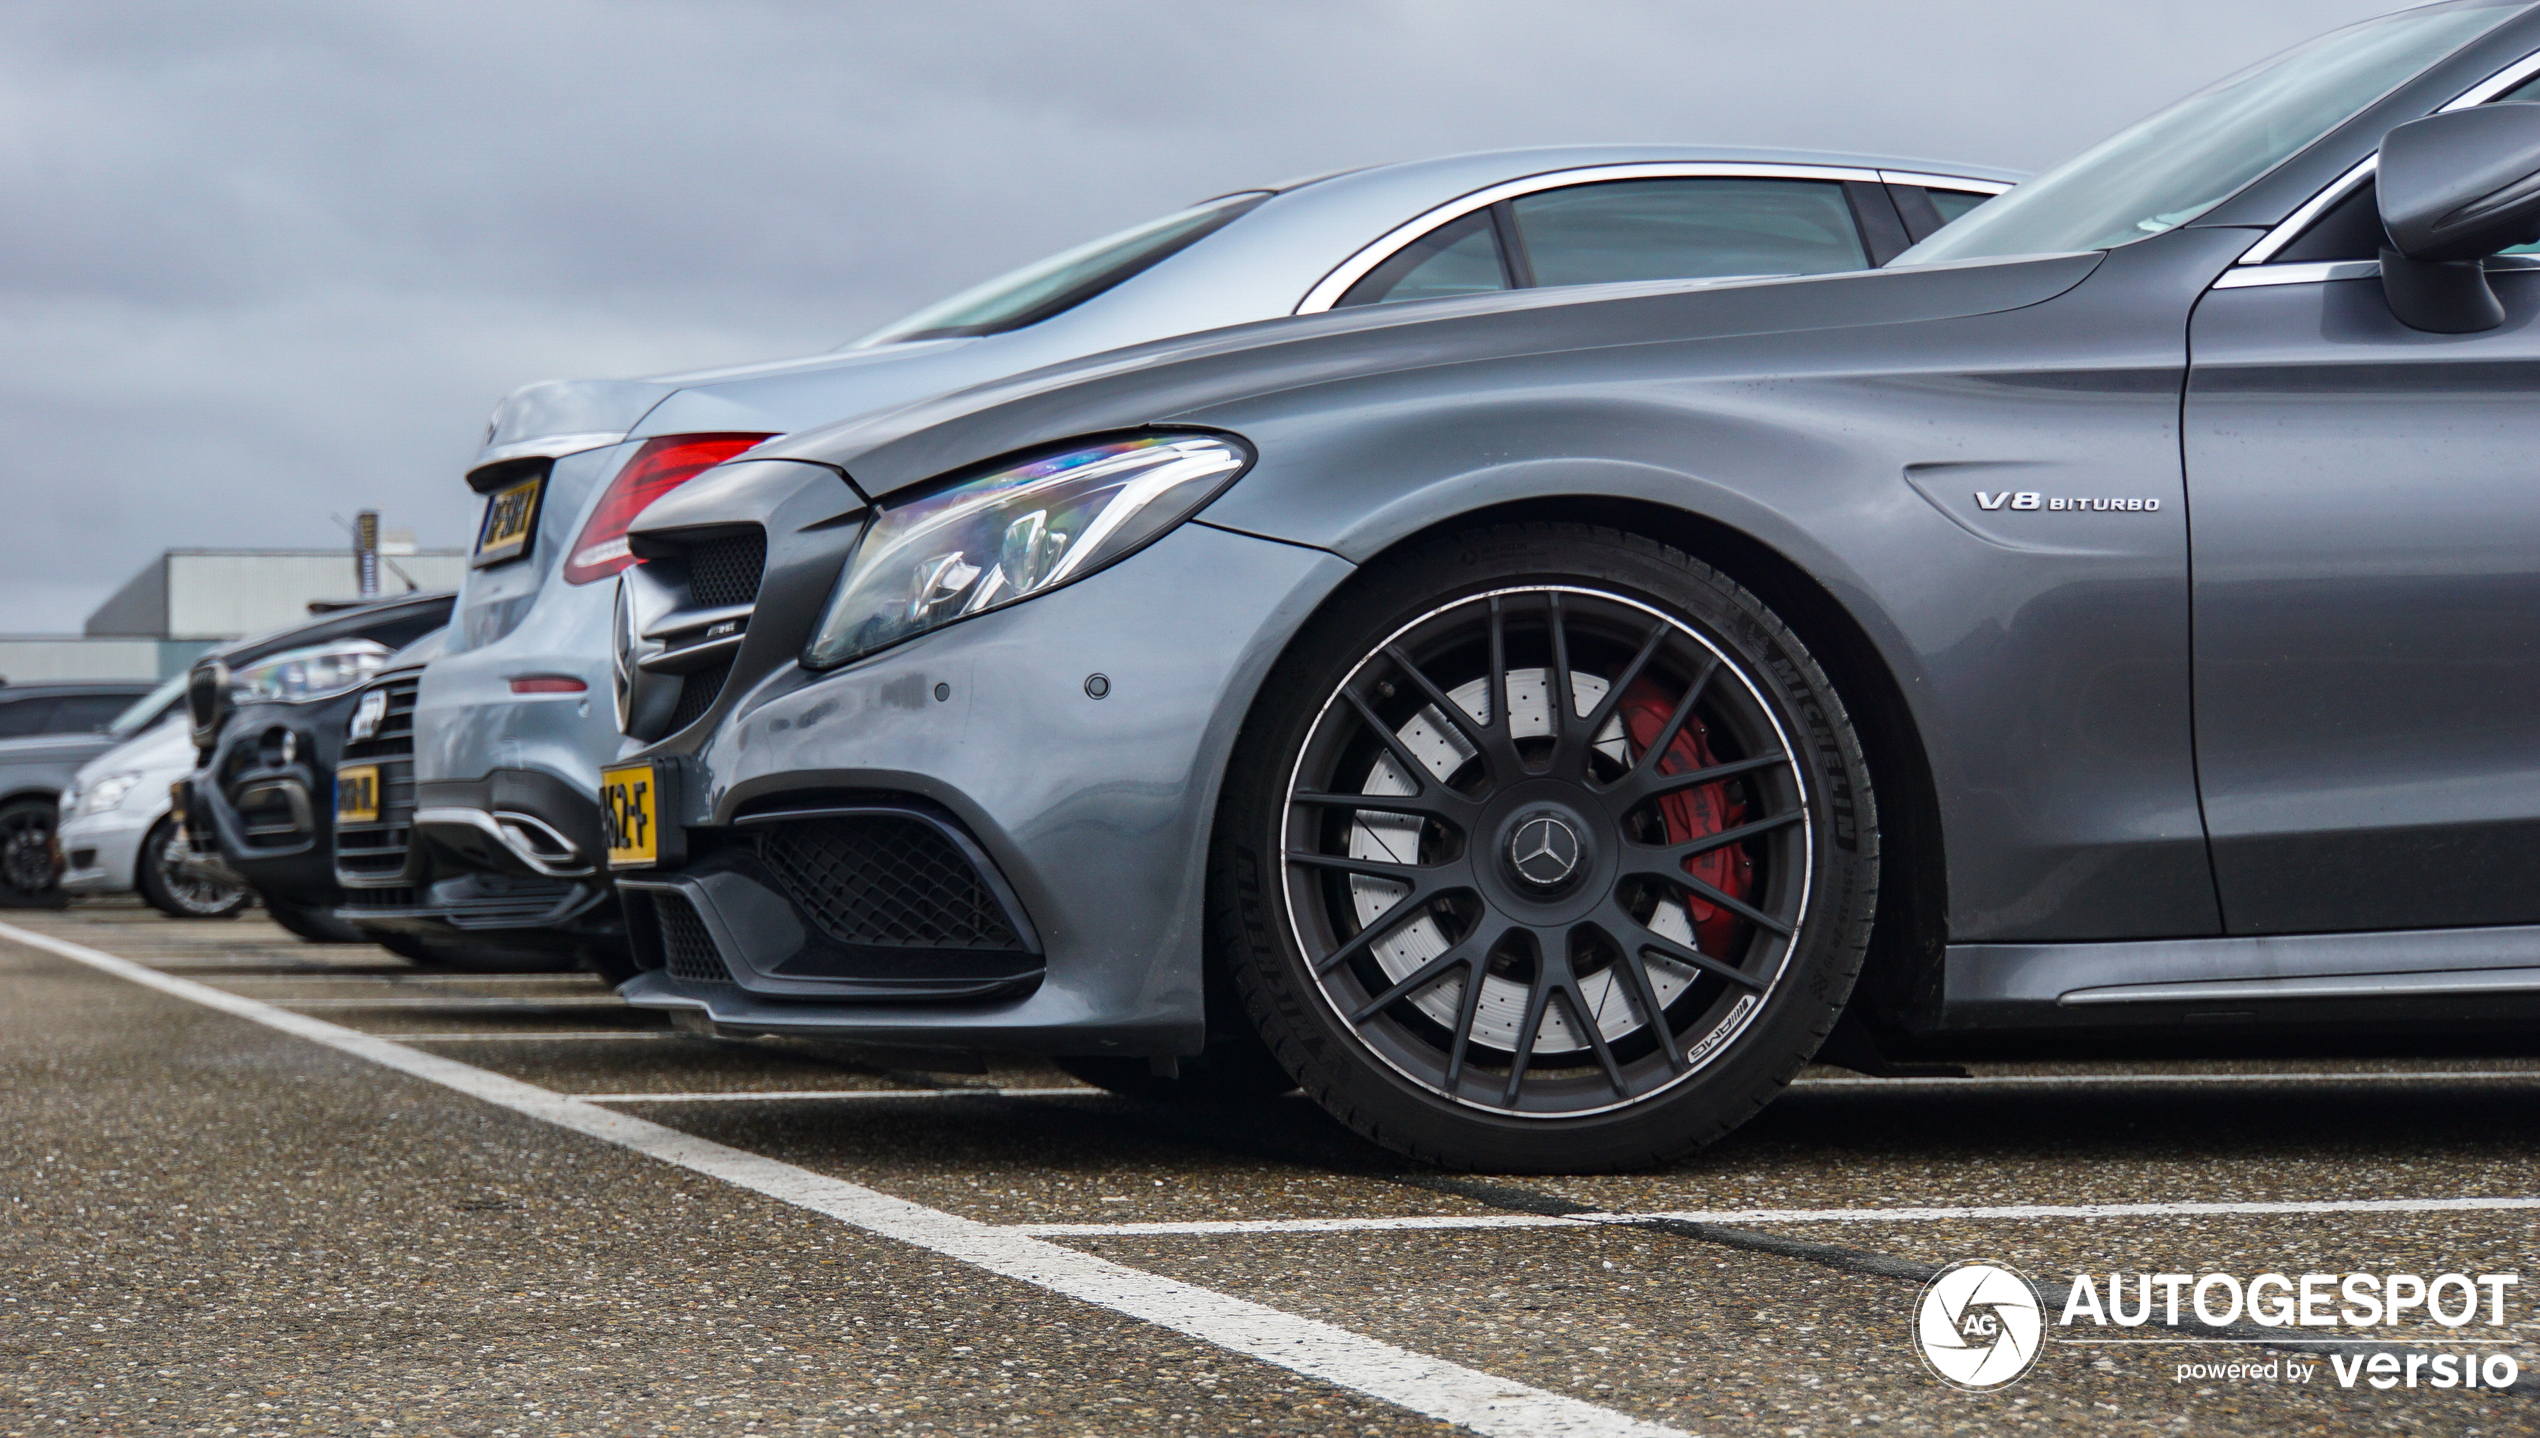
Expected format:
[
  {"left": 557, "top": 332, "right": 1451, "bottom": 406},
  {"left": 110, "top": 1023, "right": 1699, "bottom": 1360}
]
[{"left": 594, "top": 0, "right": 2540, "bottom": 1169}]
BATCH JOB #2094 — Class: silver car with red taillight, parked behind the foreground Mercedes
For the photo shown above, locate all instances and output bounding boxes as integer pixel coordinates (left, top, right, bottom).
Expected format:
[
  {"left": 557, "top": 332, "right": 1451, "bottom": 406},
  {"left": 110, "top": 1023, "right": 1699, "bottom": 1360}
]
[{"left": 375, "top": 147, "right": 2017, "bottom": 968}]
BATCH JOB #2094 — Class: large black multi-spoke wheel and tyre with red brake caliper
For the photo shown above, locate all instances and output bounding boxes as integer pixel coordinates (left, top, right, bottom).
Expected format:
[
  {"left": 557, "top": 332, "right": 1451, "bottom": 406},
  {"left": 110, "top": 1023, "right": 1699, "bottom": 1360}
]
[{"left": 1219, "top": 526, "right": 1877, "bottom": 1171}]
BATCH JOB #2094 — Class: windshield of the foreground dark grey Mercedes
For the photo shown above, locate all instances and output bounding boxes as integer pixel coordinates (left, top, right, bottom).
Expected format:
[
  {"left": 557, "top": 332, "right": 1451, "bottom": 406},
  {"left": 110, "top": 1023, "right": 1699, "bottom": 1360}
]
[{"left": 1890, "top": 0, "right": 2517, "bottom": 264}]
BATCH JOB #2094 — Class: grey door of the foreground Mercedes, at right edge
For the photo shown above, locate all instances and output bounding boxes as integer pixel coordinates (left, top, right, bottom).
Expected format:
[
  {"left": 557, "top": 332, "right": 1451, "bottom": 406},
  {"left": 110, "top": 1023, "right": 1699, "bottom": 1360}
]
[{"left": 2184, "top": 163, "right": 2540, "bottom": 935}]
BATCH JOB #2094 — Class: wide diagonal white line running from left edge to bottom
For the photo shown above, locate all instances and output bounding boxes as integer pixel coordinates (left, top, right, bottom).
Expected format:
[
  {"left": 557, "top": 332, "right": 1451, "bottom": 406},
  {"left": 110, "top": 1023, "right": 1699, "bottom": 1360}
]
[{"left": 0, "top": 925, "right": 1684, "bottom": 1438}]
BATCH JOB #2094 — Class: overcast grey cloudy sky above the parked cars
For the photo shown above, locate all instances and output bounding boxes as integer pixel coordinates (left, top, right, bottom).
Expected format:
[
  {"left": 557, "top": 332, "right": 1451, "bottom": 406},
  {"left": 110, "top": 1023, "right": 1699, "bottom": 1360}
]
[{"left": 0, "top": 0, "right": 2395, "bottom": 633}]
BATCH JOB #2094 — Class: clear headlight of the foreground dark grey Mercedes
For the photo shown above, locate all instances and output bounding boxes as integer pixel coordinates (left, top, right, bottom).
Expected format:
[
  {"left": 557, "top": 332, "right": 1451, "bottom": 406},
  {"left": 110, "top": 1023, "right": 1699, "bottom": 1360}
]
[{"left": 803, "top": 434, "right": 1252, "bottom": 668}]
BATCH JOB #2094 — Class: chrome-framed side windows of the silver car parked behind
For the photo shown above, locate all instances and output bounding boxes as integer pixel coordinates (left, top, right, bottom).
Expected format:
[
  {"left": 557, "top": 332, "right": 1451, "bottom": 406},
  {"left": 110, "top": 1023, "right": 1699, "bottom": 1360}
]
[{"left": 1334, "top": 168, "right": 1960, "bottom": 307}]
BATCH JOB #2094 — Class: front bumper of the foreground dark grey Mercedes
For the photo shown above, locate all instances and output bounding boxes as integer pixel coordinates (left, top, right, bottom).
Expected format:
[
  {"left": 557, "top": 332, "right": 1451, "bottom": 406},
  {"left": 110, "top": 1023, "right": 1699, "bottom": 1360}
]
[{"left": 620, "top": 523, "right": 1351, "bottom": 1057}]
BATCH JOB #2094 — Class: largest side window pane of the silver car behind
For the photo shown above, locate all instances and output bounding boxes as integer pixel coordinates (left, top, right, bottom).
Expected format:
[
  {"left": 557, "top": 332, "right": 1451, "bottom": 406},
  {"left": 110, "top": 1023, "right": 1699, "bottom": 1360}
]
[{"left": 1509, "top": 178, "right": 1869, "bottom": 285}]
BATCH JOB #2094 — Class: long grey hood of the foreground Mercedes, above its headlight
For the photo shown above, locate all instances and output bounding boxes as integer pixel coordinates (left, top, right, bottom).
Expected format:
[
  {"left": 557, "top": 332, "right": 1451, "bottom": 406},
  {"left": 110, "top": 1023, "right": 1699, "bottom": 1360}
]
[{"left": 752, "top": 252, "right": 2106, "bottom": 498}]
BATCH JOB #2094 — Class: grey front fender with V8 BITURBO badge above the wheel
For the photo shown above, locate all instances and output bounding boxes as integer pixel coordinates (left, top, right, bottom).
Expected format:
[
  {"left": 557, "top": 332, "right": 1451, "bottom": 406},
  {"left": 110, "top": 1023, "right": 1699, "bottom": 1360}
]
[{"left": 1171, "top": 234, "right": 2235, "bottom": 943}]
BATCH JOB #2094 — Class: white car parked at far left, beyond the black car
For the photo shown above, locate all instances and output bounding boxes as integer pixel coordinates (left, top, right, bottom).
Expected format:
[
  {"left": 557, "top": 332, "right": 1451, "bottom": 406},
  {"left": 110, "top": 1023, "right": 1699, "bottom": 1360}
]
[{"left": 56, "top": 706, "right": 249, "bottom": 920}]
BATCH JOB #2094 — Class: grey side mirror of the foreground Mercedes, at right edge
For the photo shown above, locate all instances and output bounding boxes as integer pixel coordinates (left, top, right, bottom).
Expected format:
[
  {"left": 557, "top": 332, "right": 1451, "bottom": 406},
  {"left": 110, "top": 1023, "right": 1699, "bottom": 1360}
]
[{"left": 2375, "top": 104, "right": 2540, "bottom": 335}]
